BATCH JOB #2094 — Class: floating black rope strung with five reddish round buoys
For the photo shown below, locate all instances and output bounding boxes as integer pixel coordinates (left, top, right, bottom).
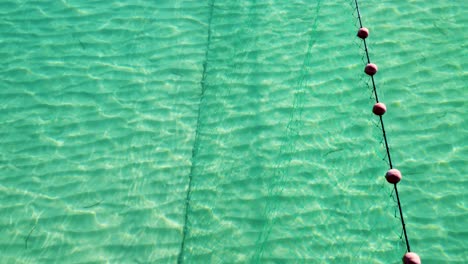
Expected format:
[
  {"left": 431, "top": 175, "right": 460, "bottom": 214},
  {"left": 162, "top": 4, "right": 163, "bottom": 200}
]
[{"left": 354, "top": 0, "right": 421, "bottom": 263}]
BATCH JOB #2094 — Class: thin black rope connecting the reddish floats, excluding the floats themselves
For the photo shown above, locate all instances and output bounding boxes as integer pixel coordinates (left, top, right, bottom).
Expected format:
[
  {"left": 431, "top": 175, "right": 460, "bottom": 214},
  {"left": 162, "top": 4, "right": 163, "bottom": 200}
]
[{"left": 354, "top": 0, "right": 411, "bottom": 252}]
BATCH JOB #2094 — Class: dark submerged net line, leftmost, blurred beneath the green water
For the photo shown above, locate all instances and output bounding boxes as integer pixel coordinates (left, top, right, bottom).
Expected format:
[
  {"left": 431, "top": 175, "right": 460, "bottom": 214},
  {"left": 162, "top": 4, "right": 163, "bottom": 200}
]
[{"left": 177, "top": 0, "right": 215, "bottom": 264}]
